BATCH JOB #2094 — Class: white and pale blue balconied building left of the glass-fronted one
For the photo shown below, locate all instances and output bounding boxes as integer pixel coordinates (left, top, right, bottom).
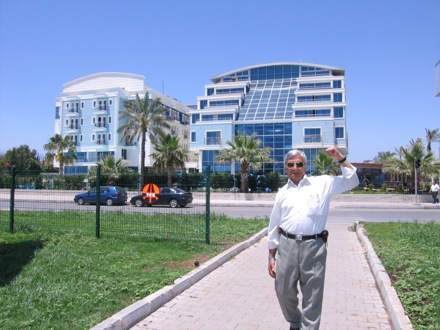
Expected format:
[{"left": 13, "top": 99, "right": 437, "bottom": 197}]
[{"left": 55, "top": 72, "right": 197, "bottom": 174}]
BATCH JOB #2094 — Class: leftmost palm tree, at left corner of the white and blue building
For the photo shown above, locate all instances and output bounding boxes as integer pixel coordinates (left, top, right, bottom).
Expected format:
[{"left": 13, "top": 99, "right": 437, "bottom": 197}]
[{"left": 44, "top": 134, "right": 77, "bottom": 176}]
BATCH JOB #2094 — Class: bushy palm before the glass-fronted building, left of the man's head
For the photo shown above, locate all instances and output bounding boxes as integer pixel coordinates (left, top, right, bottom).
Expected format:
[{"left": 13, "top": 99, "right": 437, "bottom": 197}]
[{"left": 217, "top": 134, "right": 274, "bottom": 192}]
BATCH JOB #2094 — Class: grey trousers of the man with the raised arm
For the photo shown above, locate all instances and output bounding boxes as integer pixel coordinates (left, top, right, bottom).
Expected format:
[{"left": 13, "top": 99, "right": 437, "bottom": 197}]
[{"left": 275, "top": 235, "right": 327, "bottom": 330}]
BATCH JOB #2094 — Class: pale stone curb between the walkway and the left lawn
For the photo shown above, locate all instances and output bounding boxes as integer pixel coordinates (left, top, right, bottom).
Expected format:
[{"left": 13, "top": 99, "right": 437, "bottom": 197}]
[{"left": 90, "top": 228, "right": 267, "bottom": 330}]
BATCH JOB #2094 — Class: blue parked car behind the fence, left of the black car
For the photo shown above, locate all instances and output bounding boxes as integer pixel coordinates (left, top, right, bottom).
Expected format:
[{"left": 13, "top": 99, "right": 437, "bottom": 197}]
[{"left": 73, "top": 186, "right": 127, "bottom": 206}]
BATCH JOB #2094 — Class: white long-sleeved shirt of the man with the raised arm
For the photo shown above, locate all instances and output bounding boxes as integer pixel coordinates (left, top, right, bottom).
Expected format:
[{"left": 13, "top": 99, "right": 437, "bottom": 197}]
[{"left": 268, "top": 166, "right": 359, "bottom": 249}]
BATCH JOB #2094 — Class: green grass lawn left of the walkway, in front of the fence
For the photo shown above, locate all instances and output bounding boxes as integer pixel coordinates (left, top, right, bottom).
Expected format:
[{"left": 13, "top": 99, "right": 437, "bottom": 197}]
[{"left": 0, "top": 214, "right": 268, "bottom": 330}]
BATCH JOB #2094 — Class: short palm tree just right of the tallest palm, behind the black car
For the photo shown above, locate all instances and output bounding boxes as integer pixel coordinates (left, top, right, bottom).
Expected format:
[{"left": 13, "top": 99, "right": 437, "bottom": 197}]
[{"left": 152, "top": 134, "right": 188, "bottom": 186}]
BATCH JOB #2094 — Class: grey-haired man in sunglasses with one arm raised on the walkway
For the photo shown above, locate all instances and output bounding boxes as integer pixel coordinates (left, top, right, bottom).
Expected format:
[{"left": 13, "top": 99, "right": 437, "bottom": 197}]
[{"left": 268, "top": 146, "right": 359, "bottom": 330}]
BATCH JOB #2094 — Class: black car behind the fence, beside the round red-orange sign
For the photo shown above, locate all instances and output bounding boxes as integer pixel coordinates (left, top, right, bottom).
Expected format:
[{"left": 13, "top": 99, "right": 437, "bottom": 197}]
[{"left": 130, "top": 187, "right": 193, "bottom": 207}]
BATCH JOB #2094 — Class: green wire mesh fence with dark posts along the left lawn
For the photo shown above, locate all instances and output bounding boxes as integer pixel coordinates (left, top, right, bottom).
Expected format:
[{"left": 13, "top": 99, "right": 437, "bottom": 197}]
[{"left": 0, "top": 168, "right": 210, "bottom": 244}]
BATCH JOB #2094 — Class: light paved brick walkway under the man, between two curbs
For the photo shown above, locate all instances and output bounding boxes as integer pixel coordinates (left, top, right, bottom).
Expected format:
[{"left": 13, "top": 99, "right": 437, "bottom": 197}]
[{"left": 131, "top": 226, "right": 391, "bottom": 330}]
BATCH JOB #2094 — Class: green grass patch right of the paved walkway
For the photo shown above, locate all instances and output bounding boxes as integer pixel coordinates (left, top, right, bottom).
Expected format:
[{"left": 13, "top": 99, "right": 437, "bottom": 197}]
[{"left": 364, "top": 223, "right": 440, "bottom": 330}]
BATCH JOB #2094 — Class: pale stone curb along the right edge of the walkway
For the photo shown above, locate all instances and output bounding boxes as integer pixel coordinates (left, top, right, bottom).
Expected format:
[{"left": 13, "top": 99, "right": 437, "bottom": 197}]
[{"left": 355, "top": 222, "right": 413, "bottom": 330}]
